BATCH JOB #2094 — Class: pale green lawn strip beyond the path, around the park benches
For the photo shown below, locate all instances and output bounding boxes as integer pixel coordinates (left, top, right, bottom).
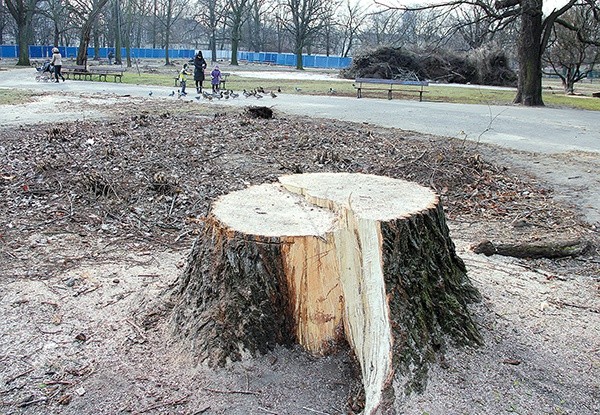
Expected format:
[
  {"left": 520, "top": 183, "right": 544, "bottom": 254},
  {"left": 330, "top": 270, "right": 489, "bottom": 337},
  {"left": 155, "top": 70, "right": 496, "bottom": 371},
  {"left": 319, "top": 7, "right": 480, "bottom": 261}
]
[{"left": 123, "top": 69, "right": 600, "bottom": 111}]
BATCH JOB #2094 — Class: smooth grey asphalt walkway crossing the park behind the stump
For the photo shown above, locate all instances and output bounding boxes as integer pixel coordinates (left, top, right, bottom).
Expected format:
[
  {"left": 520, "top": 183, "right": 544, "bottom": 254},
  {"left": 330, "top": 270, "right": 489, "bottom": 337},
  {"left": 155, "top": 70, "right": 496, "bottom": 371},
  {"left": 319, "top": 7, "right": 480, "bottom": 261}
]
[{"left": 0, "top": 68, "right": 600, "bottom": 153}]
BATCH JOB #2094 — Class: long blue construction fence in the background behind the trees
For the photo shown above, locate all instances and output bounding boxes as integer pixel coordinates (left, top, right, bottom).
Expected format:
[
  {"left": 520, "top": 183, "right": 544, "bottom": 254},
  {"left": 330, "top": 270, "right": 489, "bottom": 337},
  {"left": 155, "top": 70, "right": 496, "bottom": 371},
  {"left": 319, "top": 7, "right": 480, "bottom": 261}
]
[{"left": 0, "top": 45, "right": 352, "bottom": 69}]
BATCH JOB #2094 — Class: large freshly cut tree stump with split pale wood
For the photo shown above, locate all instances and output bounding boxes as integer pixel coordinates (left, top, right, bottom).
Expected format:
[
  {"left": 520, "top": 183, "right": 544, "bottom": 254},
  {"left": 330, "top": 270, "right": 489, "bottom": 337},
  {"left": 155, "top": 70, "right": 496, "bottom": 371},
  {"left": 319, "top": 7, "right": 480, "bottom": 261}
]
[{"left": 172, "top": 173, "right": 480, "bottom": 414}]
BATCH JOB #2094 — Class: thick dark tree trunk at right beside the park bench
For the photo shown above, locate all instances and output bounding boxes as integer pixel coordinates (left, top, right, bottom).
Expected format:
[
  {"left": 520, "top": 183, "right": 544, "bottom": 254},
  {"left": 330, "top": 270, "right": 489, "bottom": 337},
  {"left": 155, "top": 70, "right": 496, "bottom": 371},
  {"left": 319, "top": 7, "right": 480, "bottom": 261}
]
[{"left": 515, "top": 0, "right": 544, "bottom": 106}]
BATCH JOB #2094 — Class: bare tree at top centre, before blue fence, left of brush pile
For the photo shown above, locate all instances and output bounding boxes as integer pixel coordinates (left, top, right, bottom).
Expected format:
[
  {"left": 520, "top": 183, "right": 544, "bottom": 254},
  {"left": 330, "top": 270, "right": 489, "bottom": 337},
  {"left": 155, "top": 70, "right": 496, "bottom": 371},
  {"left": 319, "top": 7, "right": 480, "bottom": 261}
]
[{"left": 281, "top": 0, "right": 336, "bottom": 69}]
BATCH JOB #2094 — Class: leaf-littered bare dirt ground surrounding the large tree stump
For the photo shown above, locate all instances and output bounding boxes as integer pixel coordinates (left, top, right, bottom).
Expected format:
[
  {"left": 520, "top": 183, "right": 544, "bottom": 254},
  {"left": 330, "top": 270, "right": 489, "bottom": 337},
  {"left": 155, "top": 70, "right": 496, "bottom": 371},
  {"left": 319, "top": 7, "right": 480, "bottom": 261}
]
[{"left": 0, "top": 98, "right": 600, "bottom": 415}]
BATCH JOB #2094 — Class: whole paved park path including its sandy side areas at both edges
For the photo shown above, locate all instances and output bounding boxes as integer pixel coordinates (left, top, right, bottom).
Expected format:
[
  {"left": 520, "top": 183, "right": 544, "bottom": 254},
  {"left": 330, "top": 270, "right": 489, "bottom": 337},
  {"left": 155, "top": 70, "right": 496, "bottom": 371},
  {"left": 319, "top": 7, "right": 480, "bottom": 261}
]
[{"left": 0, "top": 68, "right": 600, "bottom": 224}]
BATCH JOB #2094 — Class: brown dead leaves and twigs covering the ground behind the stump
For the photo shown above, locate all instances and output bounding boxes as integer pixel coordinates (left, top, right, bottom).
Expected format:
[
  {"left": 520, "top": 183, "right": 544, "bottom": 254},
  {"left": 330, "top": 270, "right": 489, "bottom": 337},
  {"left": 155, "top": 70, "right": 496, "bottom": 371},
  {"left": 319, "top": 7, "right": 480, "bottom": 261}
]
[{"left": 0, "top": 105, "right": 592, "bottom": 274}]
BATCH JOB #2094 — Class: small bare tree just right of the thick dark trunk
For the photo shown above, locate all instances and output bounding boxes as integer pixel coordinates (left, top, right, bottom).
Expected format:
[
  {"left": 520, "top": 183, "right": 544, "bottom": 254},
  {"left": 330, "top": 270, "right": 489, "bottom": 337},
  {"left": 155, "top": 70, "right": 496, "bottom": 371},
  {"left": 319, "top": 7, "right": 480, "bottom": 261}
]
[{"left": 544, "top": 6, "right": 600, "bottom": 94}]
